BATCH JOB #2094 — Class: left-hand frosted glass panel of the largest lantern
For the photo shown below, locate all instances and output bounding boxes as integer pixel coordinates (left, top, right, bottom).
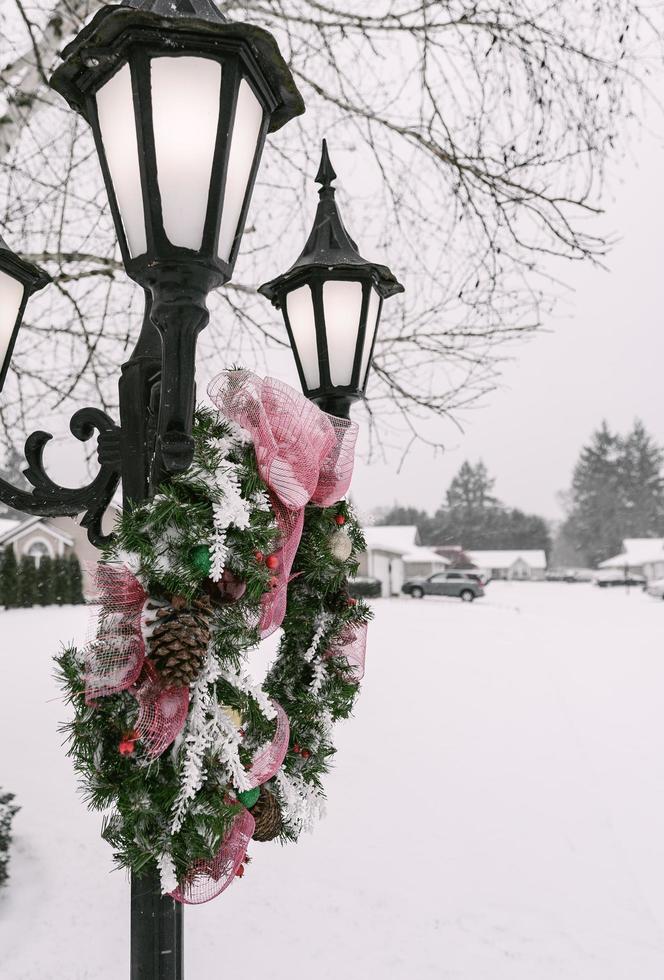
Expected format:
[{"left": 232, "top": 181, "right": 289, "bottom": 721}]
[{"left": 97, "top": 65, "right": 147, "bottom": 258}]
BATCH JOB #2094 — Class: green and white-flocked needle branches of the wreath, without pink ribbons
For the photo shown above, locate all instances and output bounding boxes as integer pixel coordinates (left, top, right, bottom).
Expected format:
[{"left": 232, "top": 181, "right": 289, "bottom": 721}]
[{"left": 58, "top": 409, "right": 370, "bottom": 900}]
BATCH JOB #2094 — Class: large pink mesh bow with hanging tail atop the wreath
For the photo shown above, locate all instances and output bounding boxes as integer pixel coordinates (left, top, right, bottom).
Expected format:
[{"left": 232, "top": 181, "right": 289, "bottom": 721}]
[{"left": 208, "top": 371, "right": 358, "bottom": 638}]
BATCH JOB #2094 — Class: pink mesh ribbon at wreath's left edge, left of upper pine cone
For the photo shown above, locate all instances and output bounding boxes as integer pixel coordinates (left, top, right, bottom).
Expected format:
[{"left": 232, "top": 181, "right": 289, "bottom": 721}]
[{"left": 84, "top": 565, "right": 147, "bottom": 704}]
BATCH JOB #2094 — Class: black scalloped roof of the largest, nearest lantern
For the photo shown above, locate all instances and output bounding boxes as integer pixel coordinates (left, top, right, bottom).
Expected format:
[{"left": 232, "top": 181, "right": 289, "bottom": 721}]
[{"left": 51, "top": 0, "right": 304, "bottom": 132}]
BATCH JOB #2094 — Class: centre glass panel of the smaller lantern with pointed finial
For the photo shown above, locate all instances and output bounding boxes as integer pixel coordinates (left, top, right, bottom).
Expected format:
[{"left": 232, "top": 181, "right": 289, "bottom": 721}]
[{"left": 323, "top": 279, "right": 362, "bottom": 388}]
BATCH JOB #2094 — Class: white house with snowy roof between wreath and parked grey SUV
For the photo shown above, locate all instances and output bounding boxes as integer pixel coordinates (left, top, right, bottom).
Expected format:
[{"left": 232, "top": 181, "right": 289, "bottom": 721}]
[{"left": 359, "top": 524, "right": 450, "bottom": 596}]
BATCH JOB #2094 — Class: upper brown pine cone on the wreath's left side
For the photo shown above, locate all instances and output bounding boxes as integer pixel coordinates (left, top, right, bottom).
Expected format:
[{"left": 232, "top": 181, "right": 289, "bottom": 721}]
[{"left": 147, "top": 596, "right": 212, "bottom": 687}]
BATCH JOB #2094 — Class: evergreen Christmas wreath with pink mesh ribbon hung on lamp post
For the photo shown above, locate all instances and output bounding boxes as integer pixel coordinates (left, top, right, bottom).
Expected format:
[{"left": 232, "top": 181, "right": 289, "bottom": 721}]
[{"left": 59, "top": 371, "right": 370, "bottom": 903}]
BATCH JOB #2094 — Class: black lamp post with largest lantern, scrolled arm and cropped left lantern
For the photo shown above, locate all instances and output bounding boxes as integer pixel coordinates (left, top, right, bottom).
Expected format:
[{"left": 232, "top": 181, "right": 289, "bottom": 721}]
[{"left": 0, "top": 0, "right": 304, "bottom": 980}]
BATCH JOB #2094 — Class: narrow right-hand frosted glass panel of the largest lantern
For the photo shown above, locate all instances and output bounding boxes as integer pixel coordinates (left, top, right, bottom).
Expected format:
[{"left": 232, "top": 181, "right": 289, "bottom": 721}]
[{"left": 218, "top": 78, "right": 263, "bottom": 262}]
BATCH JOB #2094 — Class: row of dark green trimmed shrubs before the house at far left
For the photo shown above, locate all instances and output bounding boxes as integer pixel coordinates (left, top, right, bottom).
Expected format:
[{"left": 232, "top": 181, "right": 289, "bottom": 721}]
[{"left": 0, "top": 547, "right": 85, "bottom": 609}]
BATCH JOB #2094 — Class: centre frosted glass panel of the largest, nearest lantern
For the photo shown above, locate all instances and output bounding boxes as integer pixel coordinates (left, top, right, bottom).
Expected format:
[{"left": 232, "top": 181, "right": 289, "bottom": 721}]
[{"left": 150, "top": 57, "right": 221, "bottom": 252}]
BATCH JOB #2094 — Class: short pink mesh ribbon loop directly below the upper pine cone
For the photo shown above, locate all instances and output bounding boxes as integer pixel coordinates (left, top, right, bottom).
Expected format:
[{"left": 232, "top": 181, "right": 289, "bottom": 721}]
[{"left": 132, "top": 660, "right": 189, "bottom": 759}]
